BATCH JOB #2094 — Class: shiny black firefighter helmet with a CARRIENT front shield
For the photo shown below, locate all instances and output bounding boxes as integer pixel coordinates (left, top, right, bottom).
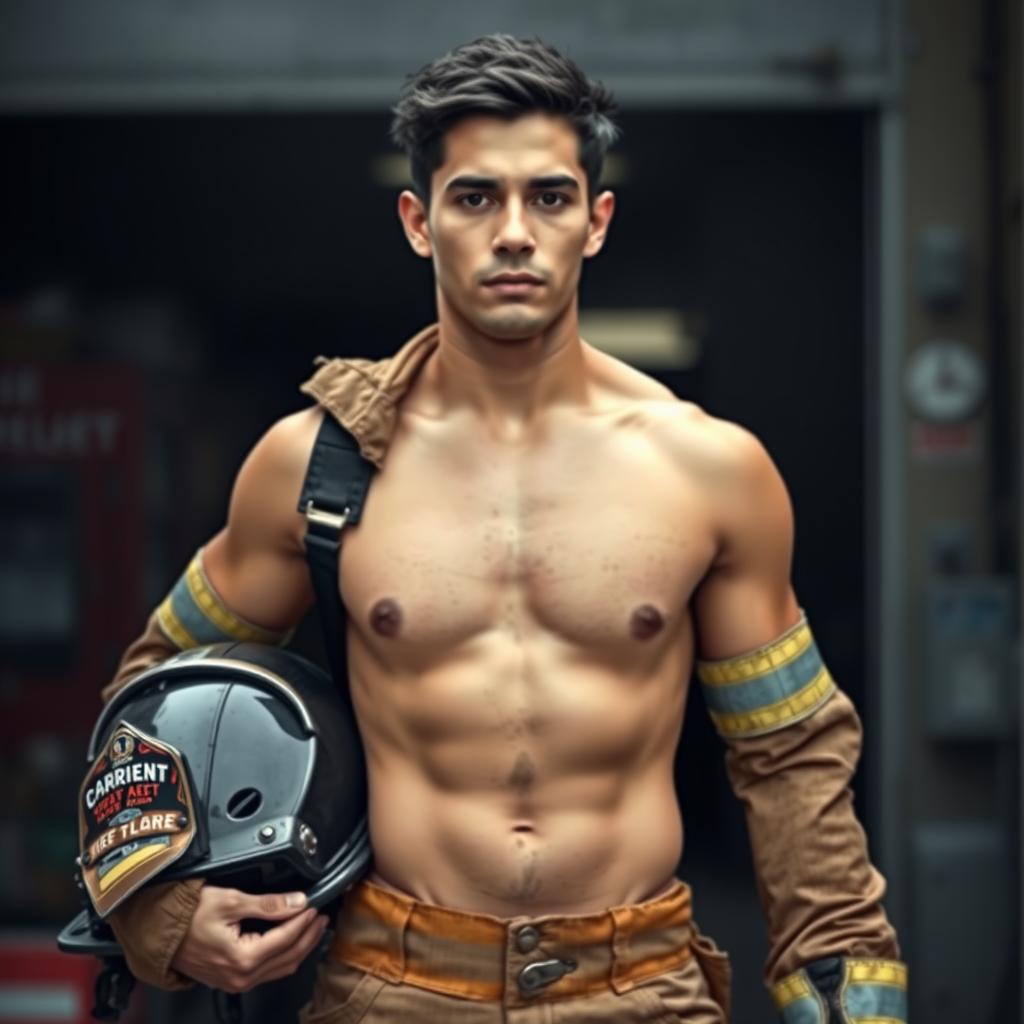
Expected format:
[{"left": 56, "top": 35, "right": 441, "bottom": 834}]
[{"left": 57, "top": 642, "right": 372, "bottom": 956}]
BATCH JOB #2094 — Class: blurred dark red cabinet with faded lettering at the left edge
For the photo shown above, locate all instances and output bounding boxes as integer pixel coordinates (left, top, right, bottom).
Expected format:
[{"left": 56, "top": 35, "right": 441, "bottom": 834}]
[{"left": 0, "top": 364, "right": 143, "bottom": 741}]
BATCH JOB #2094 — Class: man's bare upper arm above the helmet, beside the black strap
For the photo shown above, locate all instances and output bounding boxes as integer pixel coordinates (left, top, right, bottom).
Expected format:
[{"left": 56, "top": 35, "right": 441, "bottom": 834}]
[{"left": 192, "top": 409, "right": 323, "bottom": 632}]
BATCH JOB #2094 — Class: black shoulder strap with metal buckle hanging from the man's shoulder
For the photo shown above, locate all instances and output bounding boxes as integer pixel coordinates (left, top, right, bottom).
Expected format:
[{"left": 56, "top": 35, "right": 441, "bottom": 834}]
[{"left": 299, "top": 413, "right": 377, "bottom": 699}]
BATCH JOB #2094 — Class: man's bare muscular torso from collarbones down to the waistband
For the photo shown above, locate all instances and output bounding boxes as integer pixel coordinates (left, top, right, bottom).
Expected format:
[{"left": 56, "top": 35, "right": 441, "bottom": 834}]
[{"left": 341, "top": 401, "right": 714, "bottom": 915}]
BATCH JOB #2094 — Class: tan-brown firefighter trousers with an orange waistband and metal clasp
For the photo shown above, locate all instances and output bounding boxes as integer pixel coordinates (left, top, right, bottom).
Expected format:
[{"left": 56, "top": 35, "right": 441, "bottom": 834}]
[{"left": 299, "top": 879, "right": 731, "bottom": 1024}]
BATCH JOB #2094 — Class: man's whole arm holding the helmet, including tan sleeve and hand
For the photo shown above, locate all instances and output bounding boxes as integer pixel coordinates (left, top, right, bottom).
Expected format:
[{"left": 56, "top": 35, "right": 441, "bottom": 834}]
[{"left": 102, "top": 407, "right": 323, "bottom": 990}]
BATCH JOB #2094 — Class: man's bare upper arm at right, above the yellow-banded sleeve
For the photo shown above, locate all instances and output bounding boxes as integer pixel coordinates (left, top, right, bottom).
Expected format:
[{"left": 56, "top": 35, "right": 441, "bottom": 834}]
[{"left": 693, "top": 424, "right": 800, "bottom": 660}]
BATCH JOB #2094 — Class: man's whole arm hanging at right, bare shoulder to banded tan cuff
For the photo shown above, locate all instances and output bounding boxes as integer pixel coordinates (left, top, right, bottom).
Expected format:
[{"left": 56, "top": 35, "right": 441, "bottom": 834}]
[{"left": 694, "top": 421, "right": 906, "bottom": 1022}]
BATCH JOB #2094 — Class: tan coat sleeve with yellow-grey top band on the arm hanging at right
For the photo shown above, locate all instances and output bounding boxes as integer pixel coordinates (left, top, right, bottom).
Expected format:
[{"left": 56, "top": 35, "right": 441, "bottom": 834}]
[{"left": 696, "top": 612, "right": 900, "bottom": 1007}]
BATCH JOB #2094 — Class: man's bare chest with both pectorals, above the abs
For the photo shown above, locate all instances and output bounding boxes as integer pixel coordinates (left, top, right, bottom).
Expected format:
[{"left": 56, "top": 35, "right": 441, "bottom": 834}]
[{"left": 341, "top": 409, "right": 714, "bottom": 667}]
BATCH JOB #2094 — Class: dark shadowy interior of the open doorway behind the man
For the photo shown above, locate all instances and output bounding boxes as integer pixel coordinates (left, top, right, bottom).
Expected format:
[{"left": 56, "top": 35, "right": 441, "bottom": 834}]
[{"left": 0, "top": 110, "right": 870, "bottom": 1020}]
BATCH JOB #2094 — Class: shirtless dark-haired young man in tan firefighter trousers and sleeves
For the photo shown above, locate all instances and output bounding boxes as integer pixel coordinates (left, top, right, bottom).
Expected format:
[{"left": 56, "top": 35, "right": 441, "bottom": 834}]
[{"left": 105, "top": 35, "right": 905, "bottom": 1024}]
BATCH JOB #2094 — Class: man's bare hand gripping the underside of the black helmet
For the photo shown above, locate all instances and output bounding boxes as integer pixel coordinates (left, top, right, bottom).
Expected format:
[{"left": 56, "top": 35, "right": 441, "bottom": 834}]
[{"left": 171, "top": 885, "right": 328, "bottom": 992}]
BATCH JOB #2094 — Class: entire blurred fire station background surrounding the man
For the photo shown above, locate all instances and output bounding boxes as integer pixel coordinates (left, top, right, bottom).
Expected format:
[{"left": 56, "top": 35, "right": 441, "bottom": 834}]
[{"left": 0, "top": 0, "right": 1024, "bottom": 1024}]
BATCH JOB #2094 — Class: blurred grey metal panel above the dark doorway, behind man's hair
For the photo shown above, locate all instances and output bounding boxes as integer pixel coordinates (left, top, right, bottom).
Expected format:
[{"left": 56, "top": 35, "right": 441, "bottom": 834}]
[{"left": 0, "top": 0, "right": 896, "bottom": 111}]
